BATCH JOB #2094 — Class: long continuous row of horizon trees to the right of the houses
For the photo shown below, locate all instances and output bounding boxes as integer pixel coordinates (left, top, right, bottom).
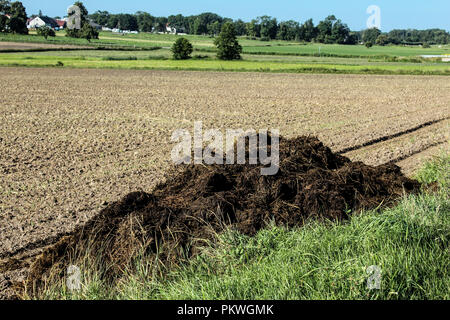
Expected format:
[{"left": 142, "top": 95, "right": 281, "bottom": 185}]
[{"left": 90, "top": 11, "right": 450, "bottom": 44}]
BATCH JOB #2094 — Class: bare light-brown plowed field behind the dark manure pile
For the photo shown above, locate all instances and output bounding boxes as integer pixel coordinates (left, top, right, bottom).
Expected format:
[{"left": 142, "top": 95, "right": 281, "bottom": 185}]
[{"left": 0, "top": 68, "right": 450, "bottom": 258}]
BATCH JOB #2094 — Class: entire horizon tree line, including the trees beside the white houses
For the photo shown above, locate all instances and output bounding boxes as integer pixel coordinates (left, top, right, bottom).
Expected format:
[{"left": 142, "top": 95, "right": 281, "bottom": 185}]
[{"left": 0, "top": 0, "right": 450, "bottom": 45}]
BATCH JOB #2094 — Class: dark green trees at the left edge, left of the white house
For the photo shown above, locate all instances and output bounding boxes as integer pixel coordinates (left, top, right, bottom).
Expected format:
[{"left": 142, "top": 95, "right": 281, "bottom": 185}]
[{"left": 0, "top": 0, "right": 28, "bottom": 34}]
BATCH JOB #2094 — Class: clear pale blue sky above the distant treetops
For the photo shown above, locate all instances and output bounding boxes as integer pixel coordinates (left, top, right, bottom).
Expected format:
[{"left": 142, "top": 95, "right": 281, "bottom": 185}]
[{"left": 22, "top": 0, "right": 450, "bottom": 31}]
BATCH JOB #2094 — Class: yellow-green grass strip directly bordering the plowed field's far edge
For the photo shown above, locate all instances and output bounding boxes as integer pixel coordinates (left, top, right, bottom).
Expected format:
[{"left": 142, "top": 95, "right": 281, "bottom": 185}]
[{"left": 0, "top": 51, "right": 450, "bottom": 75}]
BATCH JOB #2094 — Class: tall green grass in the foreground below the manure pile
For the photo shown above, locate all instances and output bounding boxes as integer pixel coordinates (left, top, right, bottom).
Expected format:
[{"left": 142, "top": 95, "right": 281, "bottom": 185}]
[{"left": 40, "top": 155, "right": 450, "bottom": 300}]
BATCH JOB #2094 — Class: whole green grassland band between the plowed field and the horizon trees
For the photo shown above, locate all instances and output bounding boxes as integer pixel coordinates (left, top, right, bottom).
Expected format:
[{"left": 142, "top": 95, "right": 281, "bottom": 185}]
[{"left": 0, "top": 32, "right": 450, "bottom": 75}]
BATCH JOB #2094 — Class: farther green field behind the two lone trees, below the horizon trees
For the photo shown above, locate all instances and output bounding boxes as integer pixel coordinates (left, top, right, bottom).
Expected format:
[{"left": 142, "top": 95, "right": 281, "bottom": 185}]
[{"left": 0, "top": 31, "right": 450, "bottom": 57}]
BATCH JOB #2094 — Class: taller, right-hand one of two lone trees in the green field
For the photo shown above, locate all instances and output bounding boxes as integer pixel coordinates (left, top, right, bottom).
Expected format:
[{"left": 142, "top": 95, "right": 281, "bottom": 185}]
[{"left": 214, "top": 22, "right": 242, "bottom": 60}]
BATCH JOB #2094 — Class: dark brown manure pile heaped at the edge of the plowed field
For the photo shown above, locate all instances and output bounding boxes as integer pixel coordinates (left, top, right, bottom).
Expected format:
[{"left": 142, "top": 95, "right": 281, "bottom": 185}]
[{"left": 16, "top": 137, "right": 420, "bottom": 296}]
